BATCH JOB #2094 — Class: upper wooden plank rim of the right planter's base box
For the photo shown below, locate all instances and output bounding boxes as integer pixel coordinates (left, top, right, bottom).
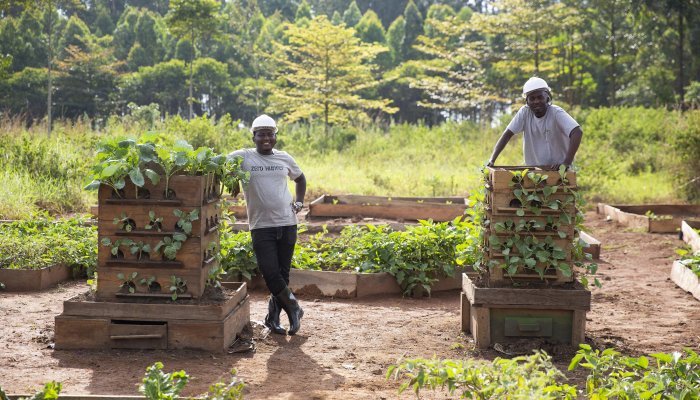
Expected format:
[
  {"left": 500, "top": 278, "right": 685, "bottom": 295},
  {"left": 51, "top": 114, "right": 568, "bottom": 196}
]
[{"left": 462, "top": 274, "right": 591, "bottom": 311}]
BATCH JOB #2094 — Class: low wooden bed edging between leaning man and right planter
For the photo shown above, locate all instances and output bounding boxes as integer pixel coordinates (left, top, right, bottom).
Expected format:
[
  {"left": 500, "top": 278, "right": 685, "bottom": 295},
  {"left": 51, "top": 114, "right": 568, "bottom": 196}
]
[{"left": 289, "top": 269, "right": 471, "bottom": 299}]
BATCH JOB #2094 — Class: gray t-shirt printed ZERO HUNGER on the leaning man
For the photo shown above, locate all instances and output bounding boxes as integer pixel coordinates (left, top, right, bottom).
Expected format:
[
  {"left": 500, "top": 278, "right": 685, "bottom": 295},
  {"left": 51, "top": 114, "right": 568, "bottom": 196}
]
[{"left": 229, "top": 148, "right": 301, "bottom": 230}]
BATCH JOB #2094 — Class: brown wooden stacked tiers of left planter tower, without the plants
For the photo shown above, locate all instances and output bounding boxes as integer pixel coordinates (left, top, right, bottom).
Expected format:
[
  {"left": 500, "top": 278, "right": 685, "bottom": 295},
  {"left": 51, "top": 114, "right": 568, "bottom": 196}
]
[{"left": 97, "top": 175, "right": 221, "bottom": 300}]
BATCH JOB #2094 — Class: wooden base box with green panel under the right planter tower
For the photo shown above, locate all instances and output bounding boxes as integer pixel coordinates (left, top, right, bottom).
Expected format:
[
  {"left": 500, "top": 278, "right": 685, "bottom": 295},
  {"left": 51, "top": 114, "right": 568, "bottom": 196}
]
[{"left": 461, "top": 274, "right": 591, "bottom": 349}]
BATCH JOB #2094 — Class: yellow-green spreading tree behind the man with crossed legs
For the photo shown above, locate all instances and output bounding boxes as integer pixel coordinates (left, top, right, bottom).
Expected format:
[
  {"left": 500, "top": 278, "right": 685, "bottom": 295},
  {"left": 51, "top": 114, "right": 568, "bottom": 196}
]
[{"left": 271, "top": 15, "right": 396, "bottom": 133}]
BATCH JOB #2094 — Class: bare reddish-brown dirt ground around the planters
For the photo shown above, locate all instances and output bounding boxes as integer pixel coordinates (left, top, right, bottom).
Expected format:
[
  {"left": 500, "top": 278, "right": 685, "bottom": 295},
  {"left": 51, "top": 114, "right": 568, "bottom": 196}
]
[{"left": 0, "top": 213, "right": 700, "bottom": 399}]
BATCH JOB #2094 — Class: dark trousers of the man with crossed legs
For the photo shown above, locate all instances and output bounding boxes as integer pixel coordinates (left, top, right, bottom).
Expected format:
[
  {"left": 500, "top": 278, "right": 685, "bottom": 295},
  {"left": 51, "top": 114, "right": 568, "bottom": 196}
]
[{"left": 250, "top": 225, "right": 297, "bottom": 295}]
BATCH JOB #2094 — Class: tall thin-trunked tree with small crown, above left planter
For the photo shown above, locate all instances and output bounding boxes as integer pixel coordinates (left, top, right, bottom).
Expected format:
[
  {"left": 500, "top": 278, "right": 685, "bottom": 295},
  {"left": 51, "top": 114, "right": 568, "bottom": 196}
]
[{"left": 167, "top": 0, "right": 219, "bottom": 120}]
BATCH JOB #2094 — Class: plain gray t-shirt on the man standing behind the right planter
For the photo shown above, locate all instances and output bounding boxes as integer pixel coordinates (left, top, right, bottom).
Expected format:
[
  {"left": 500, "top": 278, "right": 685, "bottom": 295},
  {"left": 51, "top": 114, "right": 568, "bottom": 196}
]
[{"left": 507, "top": 105, "right": 579, "bottom": 165}]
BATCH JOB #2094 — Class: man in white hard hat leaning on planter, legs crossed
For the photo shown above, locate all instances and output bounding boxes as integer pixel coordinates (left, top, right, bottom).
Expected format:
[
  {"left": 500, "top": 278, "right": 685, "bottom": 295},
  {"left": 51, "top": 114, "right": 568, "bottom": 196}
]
[{"left": 229, "top": 114, "right": 306, "bottom": 335}]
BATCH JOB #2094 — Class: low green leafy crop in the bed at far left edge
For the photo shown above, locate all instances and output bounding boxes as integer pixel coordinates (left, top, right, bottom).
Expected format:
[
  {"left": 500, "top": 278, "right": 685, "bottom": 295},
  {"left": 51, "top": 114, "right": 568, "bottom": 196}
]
[{"left": 0, "top": 213, "right": 97, "bottom": 275}]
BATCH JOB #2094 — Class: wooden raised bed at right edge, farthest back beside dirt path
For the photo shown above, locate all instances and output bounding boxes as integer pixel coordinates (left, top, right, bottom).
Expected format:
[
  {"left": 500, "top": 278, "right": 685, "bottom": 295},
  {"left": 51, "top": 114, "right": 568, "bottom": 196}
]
[{"left": 598, "top": 203, "right": 700, "bottom": 233}]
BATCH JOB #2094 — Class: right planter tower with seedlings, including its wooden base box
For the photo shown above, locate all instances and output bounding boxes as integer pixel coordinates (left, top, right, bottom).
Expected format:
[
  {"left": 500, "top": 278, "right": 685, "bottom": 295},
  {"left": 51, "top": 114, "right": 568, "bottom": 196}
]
[{"left": 461, "top": 167, "right": 599, "bottom": 348}]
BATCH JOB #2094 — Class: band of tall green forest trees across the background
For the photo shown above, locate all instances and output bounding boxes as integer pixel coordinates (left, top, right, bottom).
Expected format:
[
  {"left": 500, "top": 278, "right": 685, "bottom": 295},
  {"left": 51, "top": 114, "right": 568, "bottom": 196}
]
[{"left": 0, "top": 0, "right": 700, "bottom": 127}]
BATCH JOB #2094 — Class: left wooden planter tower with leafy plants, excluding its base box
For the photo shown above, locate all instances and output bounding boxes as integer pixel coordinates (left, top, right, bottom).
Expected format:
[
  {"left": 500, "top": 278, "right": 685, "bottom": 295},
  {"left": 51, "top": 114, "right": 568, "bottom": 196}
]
[{"left": 87, "top": 135, "right": 246, "bottom": 300}]
